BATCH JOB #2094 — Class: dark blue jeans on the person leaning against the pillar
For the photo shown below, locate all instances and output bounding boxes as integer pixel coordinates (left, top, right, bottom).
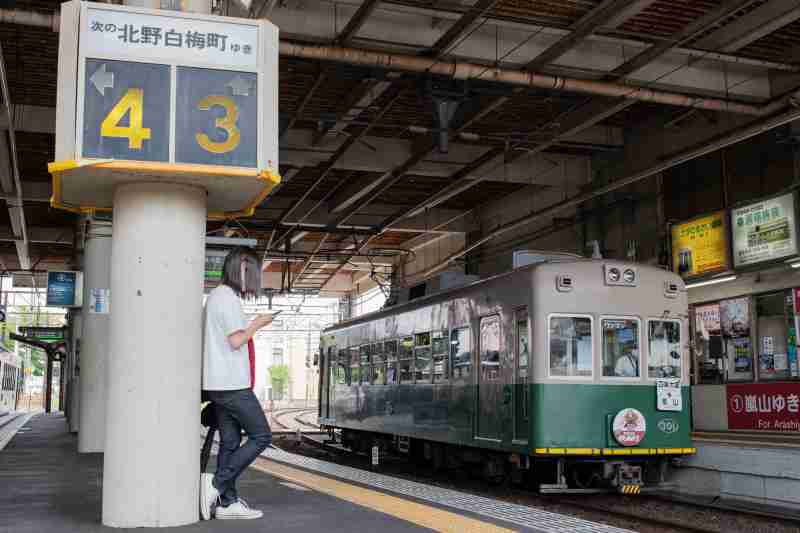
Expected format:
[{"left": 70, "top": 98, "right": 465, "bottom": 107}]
[{"left": 203, "top": 389, "right": 272, "bottom": 507}]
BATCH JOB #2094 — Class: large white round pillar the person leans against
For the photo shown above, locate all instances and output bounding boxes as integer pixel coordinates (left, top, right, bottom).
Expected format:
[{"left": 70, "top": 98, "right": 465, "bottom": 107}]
[{"left": 102, "top": 182, "right": 206, "bottom": 527}]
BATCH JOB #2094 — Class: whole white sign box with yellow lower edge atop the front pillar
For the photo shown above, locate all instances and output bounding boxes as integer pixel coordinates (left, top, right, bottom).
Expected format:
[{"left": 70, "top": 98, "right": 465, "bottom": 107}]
[{"left": 50, "top": 1, "right": 280, "bottom": 218}]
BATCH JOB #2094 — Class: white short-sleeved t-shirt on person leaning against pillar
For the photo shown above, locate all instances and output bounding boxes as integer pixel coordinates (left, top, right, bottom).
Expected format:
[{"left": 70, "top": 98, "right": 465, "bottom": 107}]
[{"left": 203, "top": 285, "right": 250, "bottom": 390}]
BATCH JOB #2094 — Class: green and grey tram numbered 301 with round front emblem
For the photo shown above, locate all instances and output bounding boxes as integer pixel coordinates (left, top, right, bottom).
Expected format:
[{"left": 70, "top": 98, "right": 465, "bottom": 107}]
[{"left": 319, "top": 259, "right": 695, "bottom": 493}]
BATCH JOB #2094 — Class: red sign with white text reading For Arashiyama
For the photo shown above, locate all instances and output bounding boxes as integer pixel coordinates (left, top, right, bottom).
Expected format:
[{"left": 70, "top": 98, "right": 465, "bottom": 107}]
[{"left": 726, "top": 383, "right": 800, "bottom": 433}]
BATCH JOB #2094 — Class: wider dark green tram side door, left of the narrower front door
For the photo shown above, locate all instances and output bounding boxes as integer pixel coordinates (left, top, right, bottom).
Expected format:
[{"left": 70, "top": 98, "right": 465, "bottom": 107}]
[{"left": 475, "top": 316, "right": 508, "bottom": 441}]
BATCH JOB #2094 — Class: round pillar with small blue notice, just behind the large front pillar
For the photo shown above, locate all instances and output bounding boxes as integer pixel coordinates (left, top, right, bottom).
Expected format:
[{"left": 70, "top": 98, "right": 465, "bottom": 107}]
[{"left": 78, "top": 220, "right": 112, "bottom": 453}]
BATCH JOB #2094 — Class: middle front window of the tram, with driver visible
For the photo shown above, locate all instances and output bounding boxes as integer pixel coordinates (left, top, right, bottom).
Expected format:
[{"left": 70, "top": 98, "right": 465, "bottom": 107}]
[{"left": 601, "top": 318, "right": 640, "bottom": 378}]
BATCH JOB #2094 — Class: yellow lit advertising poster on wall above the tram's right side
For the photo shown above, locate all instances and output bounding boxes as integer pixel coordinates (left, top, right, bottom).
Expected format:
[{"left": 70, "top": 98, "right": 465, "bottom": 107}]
[{"left": 672, "top": 211, "right": 730, "bottom": 278}]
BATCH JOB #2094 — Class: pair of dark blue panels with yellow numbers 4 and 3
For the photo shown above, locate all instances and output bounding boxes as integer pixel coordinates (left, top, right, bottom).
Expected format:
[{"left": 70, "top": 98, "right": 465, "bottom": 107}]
[{"left": 82, "top": 59, "right": 258, "bottom": 167}]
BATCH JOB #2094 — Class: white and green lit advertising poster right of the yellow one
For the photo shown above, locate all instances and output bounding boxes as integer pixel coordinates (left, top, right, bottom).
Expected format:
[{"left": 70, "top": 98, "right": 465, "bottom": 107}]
[{"left": 731, "top": 193, "right": 797, "bottom": 267}]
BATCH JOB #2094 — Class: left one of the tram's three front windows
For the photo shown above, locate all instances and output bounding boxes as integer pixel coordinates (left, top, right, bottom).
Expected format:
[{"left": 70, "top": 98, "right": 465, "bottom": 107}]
[{"left": 549, "top": 316, "right": 592, "bottom": 377}]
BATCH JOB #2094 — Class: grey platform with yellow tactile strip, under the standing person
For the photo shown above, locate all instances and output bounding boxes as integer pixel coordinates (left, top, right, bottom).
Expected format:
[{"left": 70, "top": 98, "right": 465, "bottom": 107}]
[{"left": 0, "top": 415, "right": 625, "bottom": 533}]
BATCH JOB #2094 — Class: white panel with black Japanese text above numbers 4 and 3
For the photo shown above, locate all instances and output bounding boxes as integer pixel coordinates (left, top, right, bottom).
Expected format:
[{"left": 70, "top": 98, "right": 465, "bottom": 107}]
[{"left": 81, "top": 8, "right": 258, "bottom": 70}]
